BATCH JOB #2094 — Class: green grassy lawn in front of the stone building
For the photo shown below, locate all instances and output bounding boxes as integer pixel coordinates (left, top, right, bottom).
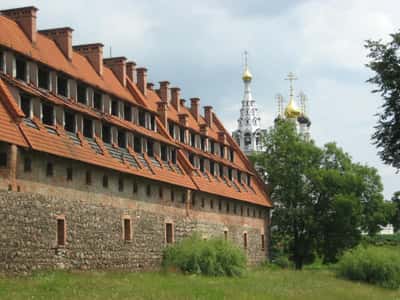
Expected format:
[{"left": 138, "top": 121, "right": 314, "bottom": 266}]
[{"left": 0, "top": 270, "right": 400, "bottom": 300}]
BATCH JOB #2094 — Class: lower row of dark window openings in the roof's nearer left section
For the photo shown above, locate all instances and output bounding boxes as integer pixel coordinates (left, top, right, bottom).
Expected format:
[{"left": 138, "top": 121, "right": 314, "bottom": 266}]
[{"left": 20, "top": 95, "right": 176, "bottom": 163}]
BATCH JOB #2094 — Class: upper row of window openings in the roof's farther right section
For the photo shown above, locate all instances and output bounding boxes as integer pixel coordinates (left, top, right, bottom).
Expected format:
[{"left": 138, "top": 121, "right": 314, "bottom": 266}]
[{"left": 168, "top": 122, "right": 235, "bottom": 162}]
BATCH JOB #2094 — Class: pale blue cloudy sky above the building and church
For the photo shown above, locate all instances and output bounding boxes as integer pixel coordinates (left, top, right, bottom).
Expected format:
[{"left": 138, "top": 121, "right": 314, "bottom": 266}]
[{"left": 0, "top": 0, "right": 400, "bottom": 199}]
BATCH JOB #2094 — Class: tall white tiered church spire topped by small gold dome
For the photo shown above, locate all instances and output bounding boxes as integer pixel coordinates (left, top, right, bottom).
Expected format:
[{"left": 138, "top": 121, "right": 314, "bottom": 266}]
[{"left": 232, "top": 51, "right": 265, "bottom": 155}]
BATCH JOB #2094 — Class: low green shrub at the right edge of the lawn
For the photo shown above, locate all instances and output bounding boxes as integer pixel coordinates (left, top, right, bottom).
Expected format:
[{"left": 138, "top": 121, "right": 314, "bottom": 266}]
[{"left": 337, "top": 246, "right": 400, "bottom": 288}]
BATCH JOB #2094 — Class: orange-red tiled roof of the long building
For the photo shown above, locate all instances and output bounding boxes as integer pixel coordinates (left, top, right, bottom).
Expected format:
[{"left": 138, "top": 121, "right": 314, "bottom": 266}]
[{"left": 0, "top": 11, "right": 272, "bottom": 207}]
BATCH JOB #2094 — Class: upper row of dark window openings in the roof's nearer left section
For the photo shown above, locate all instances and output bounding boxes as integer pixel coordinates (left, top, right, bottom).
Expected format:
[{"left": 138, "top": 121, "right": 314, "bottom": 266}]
[{"left": 0, "top": 49, "right": 156, "bottom": 131}]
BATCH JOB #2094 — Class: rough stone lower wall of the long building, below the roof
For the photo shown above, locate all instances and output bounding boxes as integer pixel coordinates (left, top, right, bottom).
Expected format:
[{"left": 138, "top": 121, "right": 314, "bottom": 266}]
[{"left": 0, "top": 191, "right": 268, "bottom": 273}]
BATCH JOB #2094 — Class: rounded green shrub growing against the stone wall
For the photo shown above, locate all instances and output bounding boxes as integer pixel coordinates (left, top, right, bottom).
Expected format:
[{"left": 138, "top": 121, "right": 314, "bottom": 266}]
[{"left": 163, "top": 234, "right": 246, "bottom": 276}]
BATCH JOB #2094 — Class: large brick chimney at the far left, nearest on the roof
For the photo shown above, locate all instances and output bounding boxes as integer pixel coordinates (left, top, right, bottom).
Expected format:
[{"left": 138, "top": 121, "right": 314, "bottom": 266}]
[{"left": 0, "top": 6, "right": 38, "bottom": 43}]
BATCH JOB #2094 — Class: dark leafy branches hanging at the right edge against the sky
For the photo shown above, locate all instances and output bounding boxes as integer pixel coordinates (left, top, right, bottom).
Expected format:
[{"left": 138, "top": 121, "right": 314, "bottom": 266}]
[{"left": 365, "top": 32, "right": 400, "bottom": 170}]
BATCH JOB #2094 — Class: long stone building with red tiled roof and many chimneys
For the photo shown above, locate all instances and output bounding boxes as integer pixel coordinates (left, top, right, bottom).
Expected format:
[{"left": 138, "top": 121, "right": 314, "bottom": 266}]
[{"left": 0, "top": 7, "right": 272, "bottom": 272}]
